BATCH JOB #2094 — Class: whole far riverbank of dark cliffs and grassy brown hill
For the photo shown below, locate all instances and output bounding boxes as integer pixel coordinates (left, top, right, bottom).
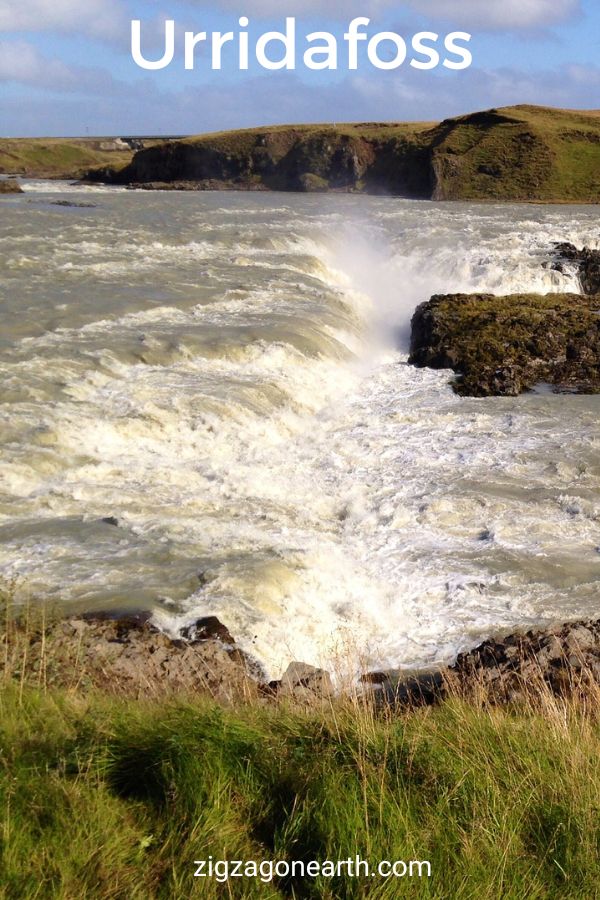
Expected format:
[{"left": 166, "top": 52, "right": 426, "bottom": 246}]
[{"left": 87, "top": 106, "right": 600, "bottom": 203}]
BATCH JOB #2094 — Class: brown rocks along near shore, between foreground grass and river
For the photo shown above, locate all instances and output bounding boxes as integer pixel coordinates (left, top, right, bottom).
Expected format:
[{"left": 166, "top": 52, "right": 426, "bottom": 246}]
[{"left": 7, "top": 611, "right": 600, "bottom": 709}]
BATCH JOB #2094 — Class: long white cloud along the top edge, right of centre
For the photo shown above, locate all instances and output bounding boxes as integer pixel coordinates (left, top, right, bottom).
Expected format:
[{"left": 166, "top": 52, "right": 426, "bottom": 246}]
[{"left": 213, "top": 0, "right": 581, "bottom": 31}]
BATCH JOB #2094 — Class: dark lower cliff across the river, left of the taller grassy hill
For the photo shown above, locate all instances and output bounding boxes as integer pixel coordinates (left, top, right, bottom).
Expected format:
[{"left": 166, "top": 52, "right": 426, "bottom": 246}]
[{"left": 102, "top": 126, "right": 432, "bottom": 197}]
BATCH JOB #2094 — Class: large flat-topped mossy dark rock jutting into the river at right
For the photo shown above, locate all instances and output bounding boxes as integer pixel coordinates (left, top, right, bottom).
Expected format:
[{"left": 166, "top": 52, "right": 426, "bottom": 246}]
[{"left": 409, "top": 294, "right": 600, "bottom": 397}]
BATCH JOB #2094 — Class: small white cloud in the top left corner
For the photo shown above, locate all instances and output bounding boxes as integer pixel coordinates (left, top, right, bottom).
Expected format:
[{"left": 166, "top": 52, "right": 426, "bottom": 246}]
[{"left": 0, "top": 0, "right": 125, "bottom": 38}]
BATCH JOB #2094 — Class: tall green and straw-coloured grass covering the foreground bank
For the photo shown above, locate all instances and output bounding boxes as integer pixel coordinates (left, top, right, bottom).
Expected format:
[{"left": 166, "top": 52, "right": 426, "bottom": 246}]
[{"left": 0, "top": 607, "right": 600, "bottom": 900}]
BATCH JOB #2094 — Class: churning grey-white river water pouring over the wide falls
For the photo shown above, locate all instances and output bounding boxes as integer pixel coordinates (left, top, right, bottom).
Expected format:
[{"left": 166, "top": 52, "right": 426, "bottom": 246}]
[{"left": 0, "top": 183, "right": 600, "bottom": 675}]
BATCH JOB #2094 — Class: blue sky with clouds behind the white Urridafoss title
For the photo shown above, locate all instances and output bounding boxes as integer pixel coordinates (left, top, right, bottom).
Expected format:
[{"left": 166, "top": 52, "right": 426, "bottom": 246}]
[{"left": 0, "top": 0, "right": 600, "bottom": 137}]
